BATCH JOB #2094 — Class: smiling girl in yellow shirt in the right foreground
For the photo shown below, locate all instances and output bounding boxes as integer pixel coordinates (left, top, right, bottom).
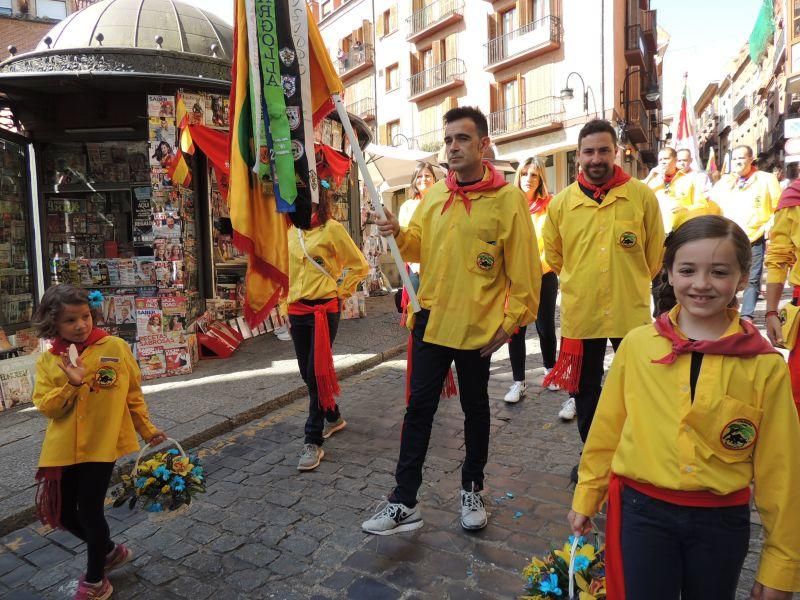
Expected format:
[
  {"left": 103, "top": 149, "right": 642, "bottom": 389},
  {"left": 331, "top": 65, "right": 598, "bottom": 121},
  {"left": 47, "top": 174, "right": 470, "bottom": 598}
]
[{"left": 569, "top": 216, "right": 800, "bottom": 600}]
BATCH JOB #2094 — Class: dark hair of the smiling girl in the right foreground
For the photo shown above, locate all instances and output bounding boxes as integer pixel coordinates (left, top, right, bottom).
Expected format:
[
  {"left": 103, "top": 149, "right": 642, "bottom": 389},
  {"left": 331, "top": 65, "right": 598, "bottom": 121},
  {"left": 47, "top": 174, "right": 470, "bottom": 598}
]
[{"left": 655, "top": 215, "right": 752, "bottom": 315}]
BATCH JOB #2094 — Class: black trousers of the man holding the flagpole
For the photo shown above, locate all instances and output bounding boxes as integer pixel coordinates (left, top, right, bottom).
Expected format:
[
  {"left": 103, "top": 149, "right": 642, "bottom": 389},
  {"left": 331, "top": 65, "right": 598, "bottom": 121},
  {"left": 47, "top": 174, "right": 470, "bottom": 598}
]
[{"left": 389, "top": 310, "right": 491, "bottom": 507}]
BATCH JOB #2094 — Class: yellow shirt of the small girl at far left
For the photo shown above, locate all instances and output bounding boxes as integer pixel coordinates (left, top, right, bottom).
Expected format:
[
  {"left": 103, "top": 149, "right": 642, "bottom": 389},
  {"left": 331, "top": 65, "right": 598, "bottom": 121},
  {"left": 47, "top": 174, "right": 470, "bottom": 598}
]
[{"left": 33, "top": 336, "right": 156, "bottom": 467}]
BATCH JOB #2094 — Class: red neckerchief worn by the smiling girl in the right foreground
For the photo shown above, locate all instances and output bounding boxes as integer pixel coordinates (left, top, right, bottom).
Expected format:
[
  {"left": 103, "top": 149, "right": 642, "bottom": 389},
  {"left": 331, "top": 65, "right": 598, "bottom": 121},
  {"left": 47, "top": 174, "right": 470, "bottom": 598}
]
[{"left": 651, "top": 312, "right": 777, "bottom": 365}]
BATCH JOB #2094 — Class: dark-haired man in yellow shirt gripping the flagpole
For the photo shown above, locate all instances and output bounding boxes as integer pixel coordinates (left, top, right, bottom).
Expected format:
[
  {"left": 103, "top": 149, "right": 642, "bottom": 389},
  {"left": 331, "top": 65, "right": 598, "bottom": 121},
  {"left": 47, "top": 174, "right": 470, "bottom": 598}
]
[{"left": 361, "top": 106, "right": 542, "bottom": 535}]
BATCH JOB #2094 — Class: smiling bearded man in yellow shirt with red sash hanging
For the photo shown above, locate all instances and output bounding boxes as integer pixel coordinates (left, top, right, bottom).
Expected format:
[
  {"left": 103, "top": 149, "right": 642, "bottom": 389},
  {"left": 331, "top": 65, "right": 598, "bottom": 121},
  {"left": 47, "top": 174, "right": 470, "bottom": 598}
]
[{"left": 543, "top": 119, "right": 664, "bottom": 480}]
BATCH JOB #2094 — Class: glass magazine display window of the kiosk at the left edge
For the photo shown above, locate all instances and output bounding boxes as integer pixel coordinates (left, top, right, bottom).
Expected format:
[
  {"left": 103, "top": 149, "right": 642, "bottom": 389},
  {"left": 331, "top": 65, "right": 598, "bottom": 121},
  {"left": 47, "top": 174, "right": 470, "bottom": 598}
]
[{"left": 0, "top": 139, "right": 34, "bottom": 334}]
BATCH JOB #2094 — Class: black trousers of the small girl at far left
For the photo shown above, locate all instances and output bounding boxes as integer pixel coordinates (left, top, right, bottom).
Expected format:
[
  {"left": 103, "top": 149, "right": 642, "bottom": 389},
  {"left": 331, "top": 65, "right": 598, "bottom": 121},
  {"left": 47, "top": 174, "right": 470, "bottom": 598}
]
[{"left": 61, "top": 462, "right": 114, "bottom": 583}]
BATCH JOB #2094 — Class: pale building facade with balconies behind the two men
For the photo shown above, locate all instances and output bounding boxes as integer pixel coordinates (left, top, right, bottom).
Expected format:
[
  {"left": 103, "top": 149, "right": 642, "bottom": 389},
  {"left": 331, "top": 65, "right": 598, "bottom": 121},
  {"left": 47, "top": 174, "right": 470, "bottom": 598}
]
[{"left": 311, "top": 0, "right": 663, "bottom": 191}]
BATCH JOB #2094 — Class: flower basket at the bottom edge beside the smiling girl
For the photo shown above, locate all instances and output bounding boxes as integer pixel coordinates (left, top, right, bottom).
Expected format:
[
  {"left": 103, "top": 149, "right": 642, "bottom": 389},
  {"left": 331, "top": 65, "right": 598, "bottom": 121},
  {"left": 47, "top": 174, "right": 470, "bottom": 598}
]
[{"left": 522, "top": 536, "right": 606, "bottom": 600}]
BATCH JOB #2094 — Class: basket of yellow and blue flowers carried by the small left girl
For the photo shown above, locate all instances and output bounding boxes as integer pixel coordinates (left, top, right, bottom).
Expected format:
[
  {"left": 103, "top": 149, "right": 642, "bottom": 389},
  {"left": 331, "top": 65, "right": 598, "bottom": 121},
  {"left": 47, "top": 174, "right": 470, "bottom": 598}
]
[{"left": 112, "top": 438, "right": 206, "bottom": 513}]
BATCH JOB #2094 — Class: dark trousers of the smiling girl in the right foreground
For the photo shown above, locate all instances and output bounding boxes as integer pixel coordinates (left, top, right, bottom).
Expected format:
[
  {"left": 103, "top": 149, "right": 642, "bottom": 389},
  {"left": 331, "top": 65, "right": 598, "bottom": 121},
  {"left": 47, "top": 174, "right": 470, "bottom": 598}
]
[{"left": 621, "top": 488, "right": 750, "bottom": 600}]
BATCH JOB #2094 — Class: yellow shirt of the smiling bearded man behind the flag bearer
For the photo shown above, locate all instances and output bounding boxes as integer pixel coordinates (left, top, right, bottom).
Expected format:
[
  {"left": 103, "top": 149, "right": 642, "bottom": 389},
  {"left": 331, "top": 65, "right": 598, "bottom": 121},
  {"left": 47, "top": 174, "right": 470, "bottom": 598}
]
[{"left": 543, "top": 179, "right": 664, "bottom": 339}]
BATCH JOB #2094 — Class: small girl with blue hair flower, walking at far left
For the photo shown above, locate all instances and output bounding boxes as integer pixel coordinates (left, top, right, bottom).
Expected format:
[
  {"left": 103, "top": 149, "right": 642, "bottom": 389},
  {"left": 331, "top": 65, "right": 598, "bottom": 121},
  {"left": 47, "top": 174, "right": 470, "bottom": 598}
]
[{"left": 33, "top": 284, "right": 166, "bottom": 600}]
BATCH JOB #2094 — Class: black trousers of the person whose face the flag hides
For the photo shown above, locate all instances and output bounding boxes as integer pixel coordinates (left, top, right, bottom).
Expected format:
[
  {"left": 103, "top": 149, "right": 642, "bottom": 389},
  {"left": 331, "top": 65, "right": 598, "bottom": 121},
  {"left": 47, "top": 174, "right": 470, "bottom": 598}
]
[{"left": 289, "top": 299, "right": 340, "bottom": 446}]
